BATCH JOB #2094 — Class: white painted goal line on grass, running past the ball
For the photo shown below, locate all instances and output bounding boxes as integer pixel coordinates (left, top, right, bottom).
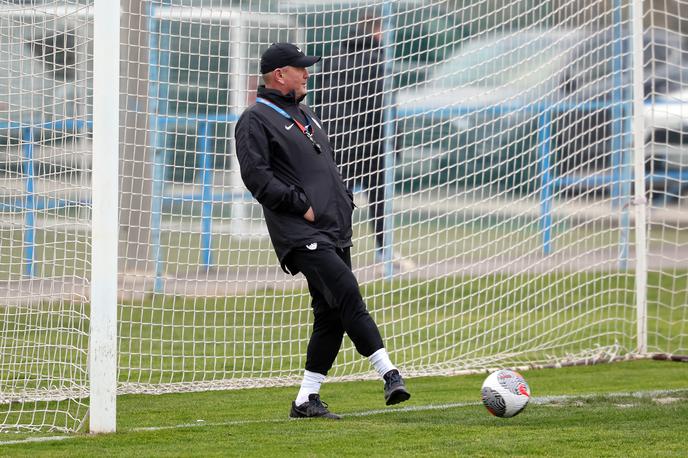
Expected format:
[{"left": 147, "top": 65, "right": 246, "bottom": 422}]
[{"left": 0, "top": 388, "right": 688, "bottom": 446}]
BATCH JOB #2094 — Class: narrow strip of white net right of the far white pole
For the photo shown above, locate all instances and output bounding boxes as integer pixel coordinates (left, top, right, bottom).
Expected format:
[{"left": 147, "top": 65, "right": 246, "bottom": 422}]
[{"left": 644, "top": 2, "right": 688, "bottom": 355}]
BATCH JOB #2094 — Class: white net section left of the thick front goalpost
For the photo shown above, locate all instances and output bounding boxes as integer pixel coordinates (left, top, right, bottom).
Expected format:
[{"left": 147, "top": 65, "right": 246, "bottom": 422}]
[{"left": 0, "top": 1, "right": 92, "bottom": 430}]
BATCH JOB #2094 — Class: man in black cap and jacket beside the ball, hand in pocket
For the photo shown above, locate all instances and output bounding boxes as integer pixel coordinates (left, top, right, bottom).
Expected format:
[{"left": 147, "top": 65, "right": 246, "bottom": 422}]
[{"left": 235, "top": 43, "right": 411, "bottom": 419}]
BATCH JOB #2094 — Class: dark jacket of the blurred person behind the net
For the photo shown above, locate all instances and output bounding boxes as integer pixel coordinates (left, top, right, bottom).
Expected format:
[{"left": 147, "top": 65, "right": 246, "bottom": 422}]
[{"left": 319, "top": 36, "right": 385, "bottom": 171}]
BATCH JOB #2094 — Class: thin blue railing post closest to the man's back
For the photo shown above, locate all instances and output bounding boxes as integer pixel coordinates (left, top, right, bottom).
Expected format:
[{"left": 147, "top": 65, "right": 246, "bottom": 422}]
[{"left": 198, "top": 121, "right": 213, "bottom": 269}]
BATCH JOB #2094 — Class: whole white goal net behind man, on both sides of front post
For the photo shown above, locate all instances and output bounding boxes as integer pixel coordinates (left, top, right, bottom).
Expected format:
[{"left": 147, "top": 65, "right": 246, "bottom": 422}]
[{"left": 0, "top": 0, "right": 688, "bottom": 431}]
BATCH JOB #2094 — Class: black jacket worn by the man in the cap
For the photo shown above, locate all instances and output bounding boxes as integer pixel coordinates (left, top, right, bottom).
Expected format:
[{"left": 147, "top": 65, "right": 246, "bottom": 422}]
[{"left": 235, "top": 86, "right": 353, "bottom": 274}]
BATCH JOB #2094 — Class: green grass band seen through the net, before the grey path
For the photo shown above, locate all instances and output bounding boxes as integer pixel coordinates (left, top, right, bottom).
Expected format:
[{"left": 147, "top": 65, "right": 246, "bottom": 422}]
[{"left": 0, "top": 273, "right": 688, "bottom": 434}]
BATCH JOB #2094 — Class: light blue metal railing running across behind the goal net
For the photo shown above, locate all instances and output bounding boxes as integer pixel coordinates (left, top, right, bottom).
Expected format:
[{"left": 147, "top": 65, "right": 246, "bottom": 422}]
[{"left": 5, "top": 103, "right": 688, "bottom": 282}]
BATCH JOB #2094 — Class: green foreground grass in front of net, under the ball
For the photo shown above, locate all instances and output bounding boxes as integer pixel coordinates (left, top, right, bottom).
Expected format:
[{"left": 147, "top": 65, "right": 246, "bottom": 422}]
[{"left": 0, "top": 361, "right": 688, "bottom": 457}]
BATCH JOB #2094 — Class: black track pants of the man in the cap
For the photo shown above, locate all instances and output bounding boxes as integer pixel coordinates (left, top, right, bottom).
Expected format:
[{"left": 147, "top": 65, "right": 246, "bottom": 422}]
[{"left": 288, "top": 244, "right": 383, "bottom": 374}]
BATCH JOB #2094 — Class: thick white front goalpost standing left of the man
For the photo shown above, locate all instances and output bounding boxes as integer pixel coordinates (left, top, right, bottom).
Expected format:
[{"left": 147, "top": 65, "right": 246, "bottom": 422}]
[{"left": 88, "top": 0, "right": 120, "bottom": 433}]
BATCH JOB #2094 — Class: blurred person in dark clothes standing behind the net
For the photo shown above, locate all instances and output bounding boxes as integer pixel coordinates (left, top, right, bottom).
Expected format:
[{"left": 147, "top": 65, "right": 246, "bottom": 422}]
[{"left": 320, "top": 9, "right": 415, "bottom": 271}]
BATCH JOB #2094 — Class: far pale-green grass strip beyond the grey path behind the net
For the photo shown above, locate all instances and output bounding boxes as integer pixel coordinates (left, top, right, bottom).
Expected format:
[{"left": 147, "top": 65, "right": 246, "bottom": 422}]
[{"left": 5, "top": 218, "right": 688, "bottom": 281}]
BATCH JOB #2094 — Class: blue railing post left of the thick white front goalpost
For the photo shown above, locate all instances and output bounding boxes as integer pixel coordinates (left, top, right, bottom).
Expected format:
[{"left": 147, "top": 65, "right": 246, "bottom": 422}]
[{"left": 22, "top": 127, "right": 36, "bottom": 277}]
